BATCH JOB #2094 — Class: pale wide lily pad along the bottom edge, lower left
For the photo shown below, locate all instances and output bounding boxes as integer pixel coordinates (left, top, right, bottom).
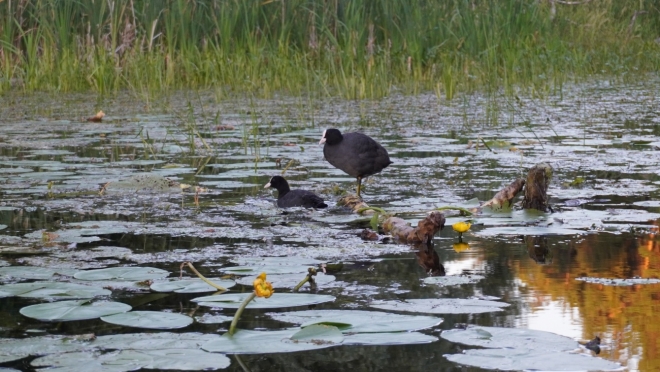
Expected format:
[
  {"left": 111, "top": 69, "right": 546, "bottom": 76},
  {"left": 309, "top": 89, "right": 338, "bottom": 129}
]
[{"left": 32, "top": 349, "right": 231, "bottom": 372}]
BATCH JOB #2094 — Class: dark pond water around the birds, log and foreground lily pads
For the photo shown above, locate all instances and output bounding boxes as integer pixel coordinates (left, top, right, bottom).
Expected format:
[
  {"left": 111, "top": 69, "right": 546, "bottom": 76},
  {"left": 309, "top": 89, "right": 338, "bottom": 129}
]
[{"left": 0, "top": 82, "right": 660, "bottom": 371}]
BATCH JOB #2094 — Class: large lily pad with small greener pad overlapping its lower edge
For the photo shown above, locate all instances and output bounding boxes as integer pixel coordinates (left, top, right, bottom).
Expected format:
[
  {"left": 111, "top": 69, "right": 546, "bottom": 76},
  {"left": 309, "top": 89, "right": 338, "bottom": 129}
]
[{"left": 268, "top": 310, "right": 442, "bottom": 333}]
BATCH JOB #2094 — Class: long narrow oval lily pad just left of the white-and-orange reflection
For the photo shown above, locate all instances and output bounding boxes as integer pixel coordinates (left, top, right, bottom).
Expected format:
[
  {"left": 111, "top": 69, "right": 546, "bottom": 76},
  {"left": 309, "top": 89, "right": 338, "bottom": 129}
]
[{"left": 370, "top": 298, "right": 509, "bottom": 314}]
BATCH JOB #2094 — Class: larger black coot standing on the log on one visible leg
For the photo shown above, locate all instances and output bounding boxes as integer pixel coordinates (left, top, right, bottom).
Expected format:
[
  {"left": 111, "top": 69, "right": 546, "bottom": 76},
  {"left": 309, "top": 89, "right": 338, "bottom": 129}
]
[{"left": 319, "top": 129, "right": 392, "bottom": 197}]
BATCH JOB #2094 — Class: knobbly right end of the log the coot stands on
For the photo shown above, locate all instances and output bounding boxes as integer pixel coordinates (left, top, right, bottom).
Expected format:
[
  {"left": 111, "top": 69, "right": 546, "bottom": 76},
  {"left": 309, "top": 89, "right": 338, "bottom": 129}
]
[{"left": 383, "top": 212, "right": 445, "bottom": 243}]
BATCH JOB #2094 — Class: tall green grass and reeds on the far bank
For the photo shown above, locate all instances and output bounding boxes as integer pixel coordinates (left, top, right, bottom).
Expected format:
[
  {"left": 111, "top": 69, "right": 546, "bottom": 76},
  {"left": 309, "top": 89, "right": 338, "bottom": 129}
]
[{"left": 0, "top": 0, "right": 660, "bottom": 98}]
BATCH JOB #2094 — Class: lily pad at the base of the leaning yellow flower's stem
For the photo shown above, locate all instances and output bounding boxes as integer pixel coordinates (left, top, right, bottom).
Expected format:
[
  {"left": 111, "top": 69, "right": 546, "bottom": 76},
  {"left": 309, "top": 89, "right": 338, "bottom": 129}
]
[{"left": 202, "top": 328, "right": 343, "bottom": 354}]
